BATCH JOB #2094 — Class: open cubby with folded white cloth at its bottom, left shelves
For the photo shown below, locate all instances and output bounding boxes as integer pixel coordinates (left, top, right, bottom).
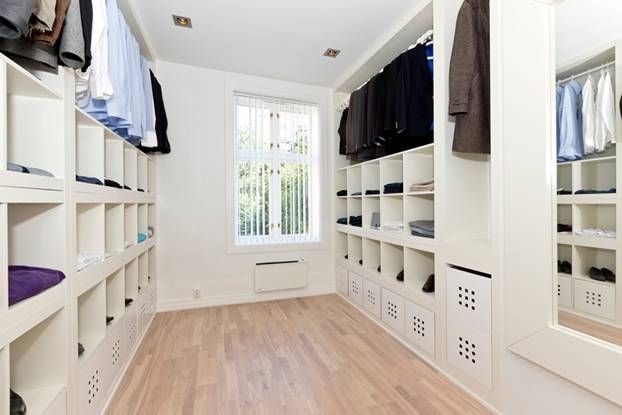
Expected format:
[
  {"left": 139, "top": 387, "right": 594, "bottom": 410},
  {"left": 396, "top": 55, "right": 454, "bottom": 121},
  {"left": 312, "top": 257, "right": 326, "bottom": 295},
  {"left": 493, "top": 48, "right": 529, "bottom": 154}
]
[{"left": 76, "top": 203, "right": 106, "bottom": 255}]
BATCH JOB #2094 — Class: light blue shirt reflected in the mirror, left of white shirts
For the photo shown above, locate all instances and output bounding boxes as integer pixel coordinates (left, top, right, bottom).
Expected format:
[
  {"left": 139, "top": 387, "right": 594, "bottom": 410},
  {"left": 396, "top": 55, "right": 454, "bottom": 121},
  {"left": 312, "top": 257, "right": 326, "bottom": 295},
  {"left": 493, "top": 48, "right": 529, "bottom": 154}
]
[{"left": 558, "top": 81, "right": 583, "bottom": 160}]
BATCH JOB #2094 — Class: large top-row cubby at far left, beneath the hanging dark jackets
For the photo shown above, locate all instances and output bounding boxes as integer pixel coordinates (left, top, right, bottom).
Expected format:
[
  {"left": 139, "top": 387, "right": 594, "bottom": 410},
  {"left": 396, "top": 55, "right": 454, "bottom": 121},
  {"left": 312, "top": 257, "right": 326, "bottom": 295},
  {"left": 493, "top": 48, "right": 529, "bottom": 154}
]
[{"left": 2, "top": 83, "right": 65, "bottom": 178}]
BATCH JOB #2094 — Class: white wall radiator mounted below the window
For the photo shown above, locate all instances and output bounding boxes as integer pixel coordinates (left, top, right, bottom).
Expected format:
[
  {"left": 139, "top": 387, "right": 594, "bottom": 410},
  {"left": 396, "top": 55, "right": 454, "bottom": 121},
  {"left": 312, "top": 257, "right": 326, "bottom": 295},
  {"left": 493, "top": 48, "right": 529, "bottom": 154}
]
[{"left": 255, "top": 259, "right": 309, "bottom": 292}]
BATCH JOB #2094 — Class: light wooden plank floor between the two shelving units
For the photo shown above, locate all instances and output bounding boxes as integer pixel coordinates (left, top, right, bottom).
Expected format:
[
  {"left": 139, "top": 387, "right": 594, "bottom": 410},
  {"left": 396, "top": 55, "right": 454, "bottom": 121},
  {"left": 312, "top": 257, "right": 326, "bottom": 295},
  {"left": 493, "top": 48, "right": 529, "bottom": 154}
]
[{"left": 108, "top": 295, "right": 489, "bottom": 415}]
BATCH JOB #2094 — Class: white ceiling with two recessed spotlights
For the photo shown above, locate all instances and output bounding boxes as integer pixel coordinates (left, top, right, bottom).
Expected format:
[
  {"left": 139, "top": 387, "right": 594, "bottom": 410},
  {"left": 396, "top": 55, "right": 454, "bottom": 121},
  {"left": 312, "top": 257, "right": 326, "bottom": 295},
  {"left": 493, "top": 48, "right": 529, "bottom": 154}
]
[{"left": 134, "top": 0, "right": 422, "bottom": 87}]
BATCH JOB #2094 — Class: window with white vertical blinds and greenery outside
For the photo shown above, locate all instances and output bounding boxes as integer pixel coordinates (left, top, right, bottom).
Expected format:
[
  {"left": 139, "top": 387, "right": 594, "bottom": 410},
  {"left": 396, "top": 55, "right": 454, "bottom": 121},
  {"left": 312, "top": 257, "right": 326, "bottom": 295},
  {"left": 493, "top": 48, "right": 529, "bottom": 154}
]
[{"left": 234, "top": 94, "right": 319, "bottom": 245}]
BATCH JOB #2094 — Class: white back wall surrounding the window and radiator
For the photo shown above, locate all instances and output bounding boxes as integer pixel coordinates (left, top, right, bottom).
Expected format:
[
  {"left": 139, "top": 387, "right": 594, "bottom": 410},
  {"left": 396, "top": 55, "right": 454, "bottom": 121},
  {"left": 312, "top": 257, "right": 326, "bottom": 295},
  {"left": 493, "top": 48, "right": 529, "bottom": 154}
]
[{"left": 157, "top": 62, "right": 335, "bottom": 310}]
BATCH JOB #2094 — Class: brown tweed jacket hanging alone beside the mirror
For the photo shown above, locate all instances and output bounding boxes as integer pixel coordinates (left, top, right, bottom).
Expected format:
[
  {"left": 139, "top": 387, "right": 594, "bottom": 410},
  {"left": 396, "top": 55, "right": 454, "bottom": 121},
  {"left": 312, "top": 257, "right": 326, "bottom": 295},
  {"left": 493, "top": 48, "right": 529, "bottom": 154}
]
[{"left": 449, "top": 0, "right": 490, "bottom": 154}]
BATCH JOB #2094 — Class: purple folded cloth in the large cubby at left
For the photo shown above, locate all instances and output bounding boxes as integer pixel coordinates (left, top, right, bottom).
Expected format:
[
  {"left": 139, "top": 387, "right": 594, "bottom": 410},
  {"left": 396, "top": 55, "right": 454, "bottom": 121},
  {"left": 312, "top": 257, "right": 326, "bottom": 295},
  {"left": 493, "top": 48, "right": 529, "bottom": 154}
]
[{"left": 9, "top": 265, "right": 65, "bottom": 305}]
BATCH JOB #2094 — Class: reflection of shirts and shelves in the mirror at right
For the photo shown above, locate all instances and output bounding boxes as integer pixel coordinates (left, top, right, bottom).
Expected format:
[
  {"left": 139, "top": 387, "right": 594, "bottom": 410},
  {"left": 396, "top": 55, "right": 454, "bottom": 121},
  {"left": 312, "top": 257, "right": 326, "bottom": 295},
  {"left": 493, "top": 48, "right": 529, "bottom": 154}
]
[{"left": 553, "top": 0, "right": 622, "bottom": 346}]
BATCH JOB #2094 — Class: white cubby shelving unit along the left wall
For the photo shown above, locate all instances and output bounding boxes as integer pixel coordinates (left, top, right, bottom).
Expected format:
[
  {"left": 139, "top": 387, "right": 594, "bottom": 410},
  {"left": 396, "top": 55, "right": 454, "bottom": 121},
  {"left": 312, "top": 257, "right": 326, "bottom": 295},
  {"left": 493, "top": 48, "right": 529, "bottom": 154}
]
[{"left": 0, "top": 54, "right": 157, "bottom": 415}]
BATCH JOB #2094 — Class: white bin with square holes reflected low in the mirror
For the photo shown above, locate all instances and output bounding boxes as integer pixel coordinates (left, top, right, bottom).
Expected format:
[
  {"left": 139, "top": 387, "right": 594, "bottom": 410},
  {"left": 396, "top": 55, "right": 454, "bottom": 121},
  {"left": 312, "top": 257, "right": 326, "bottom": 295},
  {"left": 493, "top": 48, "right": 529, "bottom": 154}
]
[{"left": 574, "top": 280, "right": 616, "bottom": 320}]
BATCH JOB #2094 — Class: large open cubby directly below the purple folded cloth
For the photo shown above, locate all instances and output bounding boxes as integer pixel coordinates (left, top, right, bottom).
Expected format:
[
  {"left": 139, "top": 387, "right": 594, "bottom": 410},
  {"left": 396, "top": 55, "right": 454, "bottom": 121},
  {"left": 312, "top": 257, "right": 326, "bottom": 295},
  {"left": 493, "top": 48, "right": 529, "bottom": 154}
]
[{"left": 7, "top": 309, "right": 67, "bottom": 415}]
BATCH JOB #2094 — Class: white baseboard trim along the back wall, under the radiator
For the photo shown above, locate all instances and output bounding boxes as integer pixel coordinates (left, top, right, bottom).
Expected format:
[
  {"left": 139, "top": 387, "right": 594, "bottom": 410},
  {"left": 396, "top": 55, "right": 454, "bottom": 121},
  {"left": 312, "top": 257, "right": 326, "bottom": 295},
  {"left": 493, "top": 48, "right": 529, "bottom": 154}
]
[{"left": 158, "top": 283, "right": 337, "bottom": 313}]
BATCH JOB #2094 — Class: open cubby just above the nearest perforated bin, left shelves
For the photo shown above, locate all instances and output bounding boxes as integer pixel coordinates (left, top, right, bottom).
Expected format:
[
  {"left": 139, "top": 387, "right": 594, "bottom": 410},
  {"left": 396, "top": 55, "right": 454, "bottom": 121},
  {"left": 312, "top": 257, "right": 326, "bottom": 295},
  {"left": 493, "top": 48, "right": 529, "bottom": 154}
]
[{"left": 75, "top": 281, "right": 106, "bottom": 360}]
